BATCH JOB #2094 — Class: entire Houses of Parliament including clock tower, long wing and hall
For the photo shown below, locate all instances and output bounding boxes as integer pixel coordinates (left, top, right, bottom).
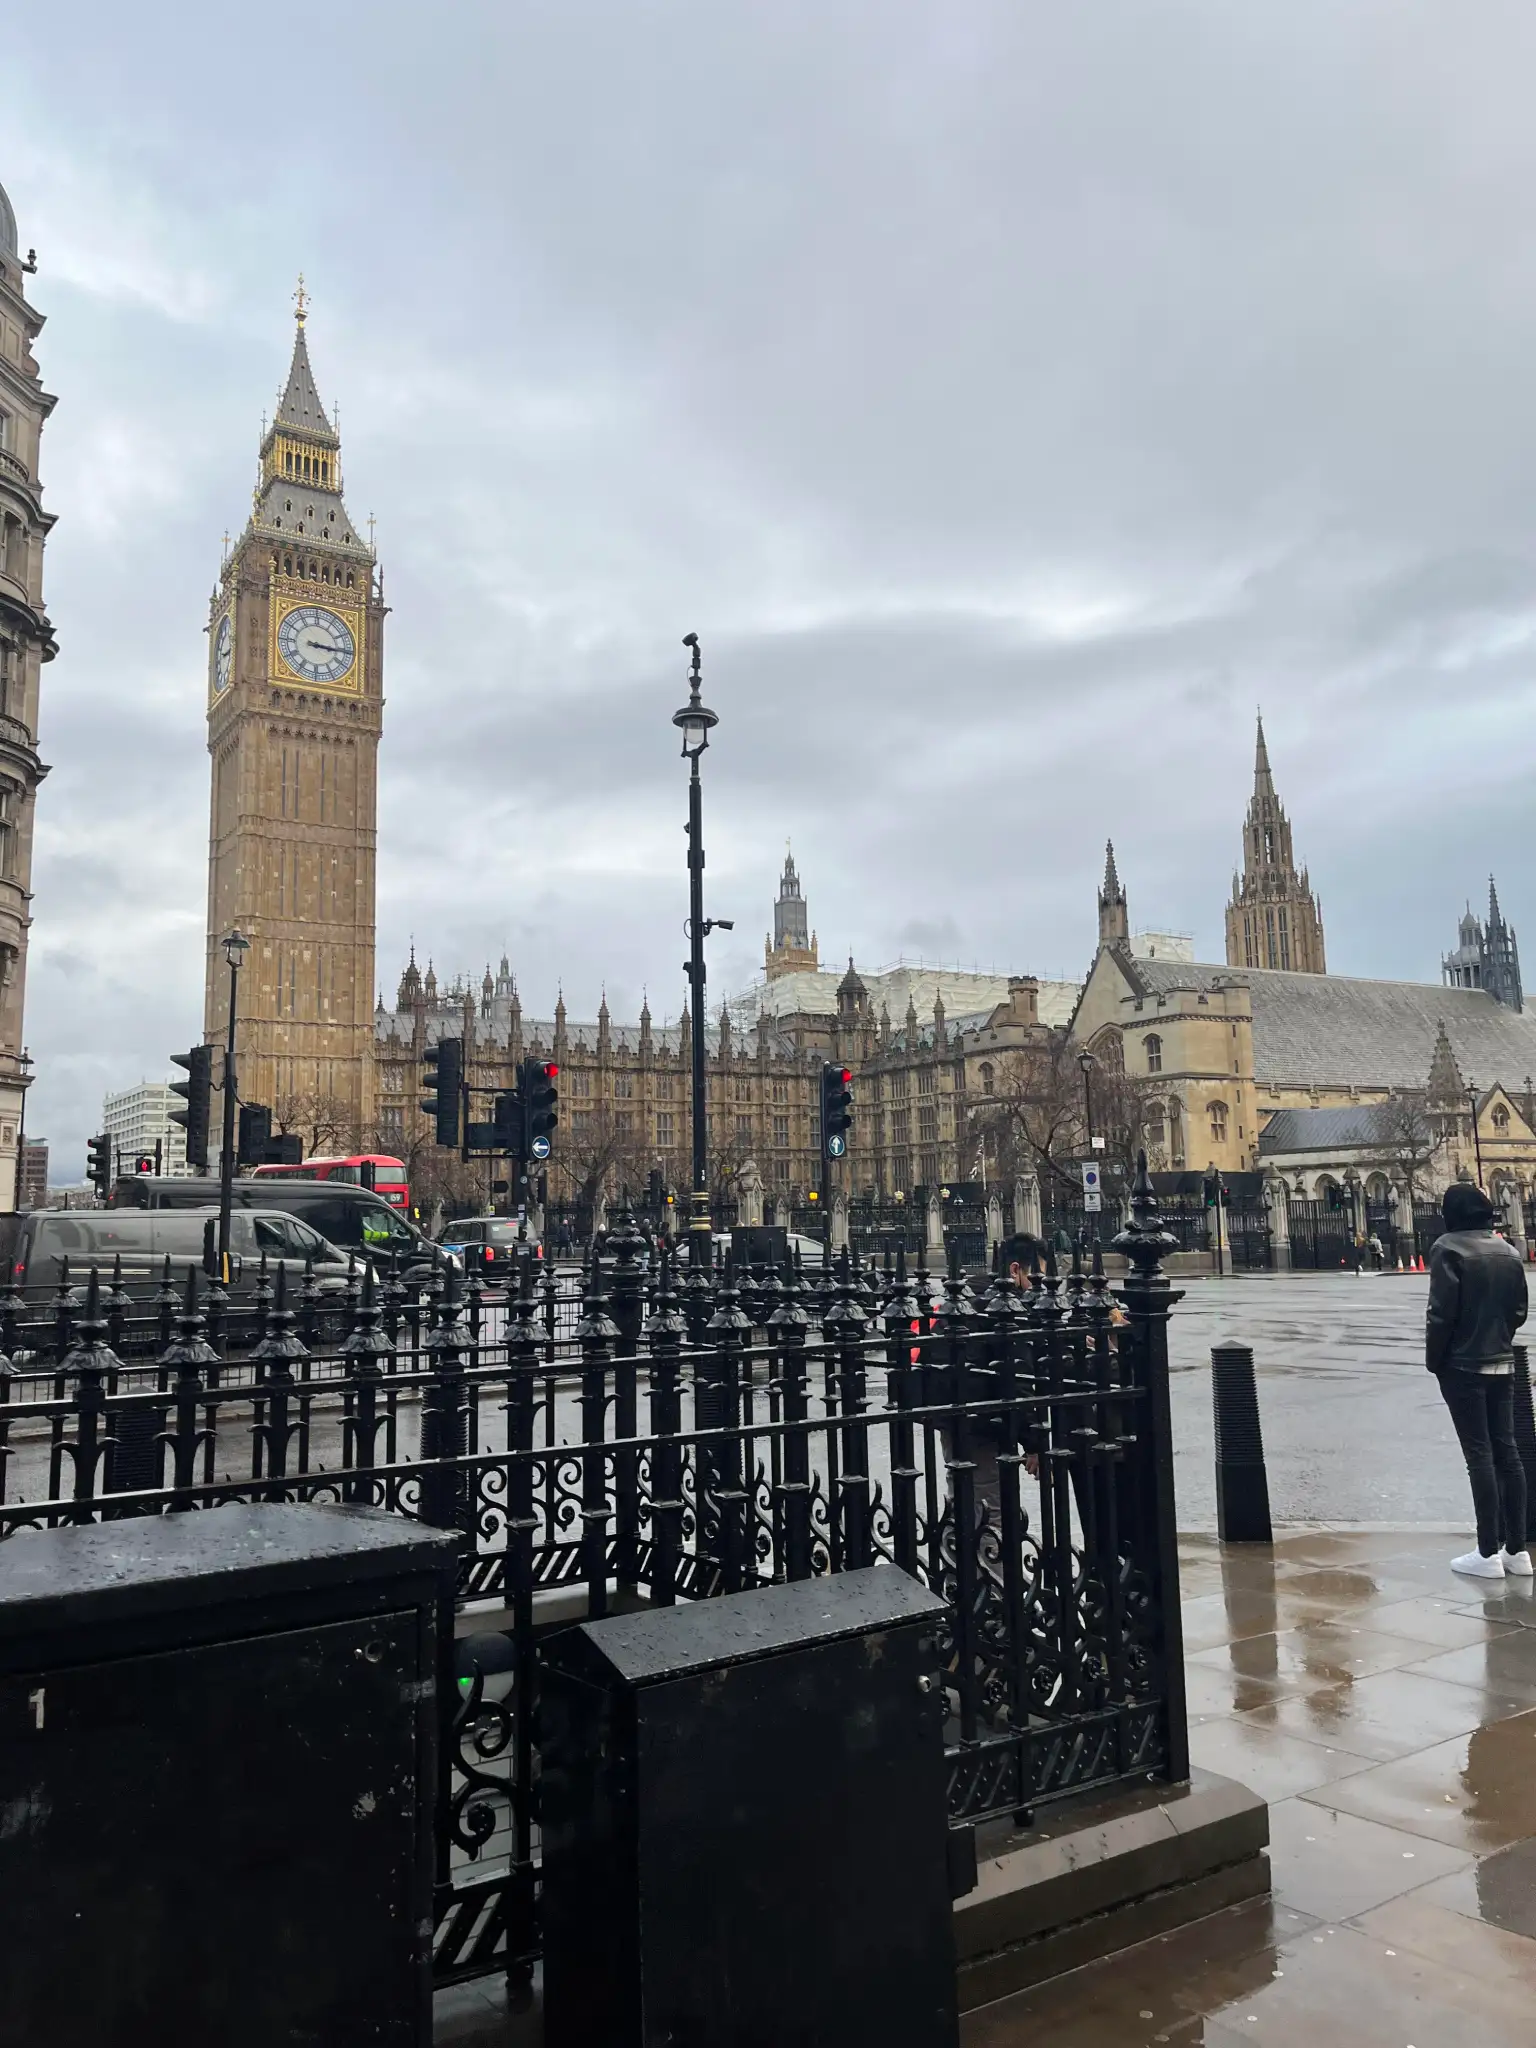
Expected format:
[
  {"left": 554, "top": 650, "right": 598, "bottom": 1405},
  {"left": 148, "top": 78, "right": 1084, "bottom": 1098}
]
[{"left": 205, "top": 309, "right": 1536, "bottom": 1198}]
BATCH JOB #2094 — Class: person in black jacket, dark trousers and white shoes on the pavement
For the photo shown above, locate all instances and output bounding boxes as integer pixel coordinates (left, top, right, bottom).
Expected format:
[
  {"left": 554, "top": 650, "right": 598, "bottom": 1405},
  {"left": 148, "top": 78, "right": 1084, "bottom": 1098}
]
[{"left": 1423, "top": 1182, "right": 1532, "bottom": 1579}]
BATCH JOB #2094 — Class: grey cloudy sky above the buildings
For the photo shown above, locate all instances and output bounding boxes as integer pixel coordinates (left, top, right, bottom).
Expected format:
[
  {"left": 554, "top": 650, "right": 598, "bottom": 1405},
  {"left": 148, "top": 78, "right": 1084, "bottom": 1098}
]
[{"left": 0, "top": 0, "right": 1536, "bottom": 1180}]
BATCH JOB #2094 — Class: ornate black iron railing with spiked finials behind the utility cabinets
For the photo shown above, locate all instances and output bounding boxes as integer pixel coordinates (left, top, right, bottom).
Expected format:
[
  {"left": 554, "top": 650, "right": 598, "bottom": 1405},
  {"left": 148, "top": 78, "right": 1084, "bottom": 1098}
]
[{"left": 0, "top": 1174, "right": 1188, "bottom": 1980}]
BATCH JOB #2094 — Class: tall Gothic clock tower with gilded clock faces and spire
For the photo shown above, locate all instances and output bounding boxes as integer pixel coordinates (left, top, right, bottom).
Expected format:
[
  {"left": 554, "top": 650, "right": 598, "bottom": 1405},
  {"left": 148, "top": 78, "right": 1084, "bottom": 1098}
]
[{"left": 205, "top": 292, "right": 385, "bottom": 1143}]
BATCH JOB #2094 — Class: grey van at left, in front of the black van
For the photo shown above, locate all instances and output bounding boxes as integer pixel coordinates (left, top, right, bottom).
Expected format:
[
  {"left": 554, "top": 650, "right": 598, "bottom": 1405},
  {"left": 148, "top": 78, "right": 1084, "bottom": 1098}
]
[{"left": 0, "top": 1208, "right": 348, "bottom": 1298}]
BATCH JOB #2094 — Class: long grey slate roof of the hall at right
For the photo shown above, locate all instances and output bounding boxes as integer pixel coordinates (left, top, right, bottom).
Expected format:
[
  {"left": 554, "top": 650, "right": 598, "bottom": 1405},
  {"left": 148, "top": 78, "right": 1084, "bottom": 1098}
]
[{"left": 1122, "top": 961, "right": 1536, "bottom": 1087}]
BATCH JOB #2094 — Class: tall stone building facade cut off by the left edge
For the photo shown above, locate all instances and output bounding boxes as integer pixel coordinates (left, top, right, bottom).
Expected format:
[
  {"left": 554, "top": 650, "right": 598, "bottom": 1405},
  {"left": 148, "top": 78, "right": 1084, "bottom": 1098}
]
[{"left": 0, "top": 188, "right": 57, "bottom": 1208}]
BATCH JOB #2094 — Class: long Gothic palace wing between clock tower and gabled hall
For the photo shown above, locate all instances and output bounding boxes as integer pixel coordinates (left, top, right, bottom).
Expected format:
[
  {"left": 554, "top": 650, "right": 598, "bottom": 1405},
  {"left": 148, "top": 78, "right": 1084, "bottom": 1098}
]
[{"left": 375, "top": 860, "right": 1075, "bottom": 1202}]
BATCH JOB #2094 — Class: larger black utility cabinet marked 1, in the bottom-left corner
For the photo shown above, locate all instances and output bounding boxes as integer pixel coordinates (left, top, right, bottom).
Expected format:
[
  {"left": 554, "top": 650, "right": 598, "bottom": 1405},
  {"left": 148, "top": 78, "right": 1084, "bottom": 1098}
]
[{"left": 0, "top": 1505, "right": 457, "bottom": 2048}]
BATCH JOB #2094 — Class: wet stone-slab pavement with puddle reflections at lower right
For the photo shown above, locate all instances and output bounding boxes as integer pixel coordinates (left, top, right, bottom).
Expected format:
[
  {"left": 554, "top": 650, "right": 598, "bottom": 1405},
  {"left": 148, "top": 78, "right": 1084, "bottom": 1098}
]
[{"left": 436, "top": 1531, "right": 1536, "bottom": 2048}]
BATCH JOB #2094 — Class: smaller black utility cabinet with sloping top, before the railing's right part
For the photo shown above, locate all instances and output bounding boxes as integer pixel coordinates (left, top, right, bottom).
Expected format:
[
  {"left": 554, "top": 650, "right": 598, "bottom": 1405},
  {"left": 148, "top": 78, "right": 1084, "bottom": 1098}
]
[{"left": 541, "top": 1569, "right": 956, "bottom": 2048}]
